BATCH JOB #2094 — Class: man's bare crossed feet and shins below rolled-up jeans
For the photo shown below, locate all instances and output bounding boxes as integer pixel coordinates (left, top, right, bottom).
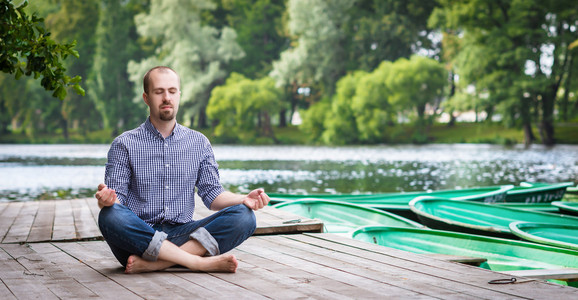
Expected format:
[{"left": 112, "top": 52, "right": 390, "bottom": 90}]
[{"left": 125, "top": 240, "right": 238, "bottom": 274}]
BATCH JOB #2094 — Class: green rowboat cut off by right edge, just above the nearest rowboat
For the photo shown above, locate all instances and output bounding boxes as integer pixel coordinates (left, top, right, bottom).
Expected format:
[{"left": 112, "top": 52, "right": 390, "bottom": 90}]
[{"left": 510, "top": 222, "right": 578, "bottom": 250}]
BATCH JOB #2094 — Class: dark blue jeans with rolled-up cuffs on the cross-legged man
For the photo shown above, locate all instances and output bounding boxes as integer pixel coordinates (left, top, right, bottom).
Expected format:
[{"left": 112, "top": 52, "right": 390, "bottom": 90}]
[{"left": 98, "top": 204, "right": 257, "bottom": 266}]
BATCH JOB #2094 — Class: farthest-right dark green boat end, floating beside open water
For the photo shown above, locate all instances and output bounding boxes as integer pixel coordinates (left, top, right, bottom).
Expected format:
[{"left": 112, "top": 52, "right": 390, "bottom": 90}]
[{"left": 505, "top": 182, "right": 574, "bottom": 203}]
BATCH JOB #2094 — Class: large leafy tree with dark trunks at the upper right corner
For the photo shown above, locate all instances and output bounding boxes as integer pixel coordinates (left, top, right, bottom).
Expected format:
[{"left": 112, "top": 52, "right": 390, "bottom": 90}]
[{"left": 430, "top": 0, "right": 578, "bottom": 145}]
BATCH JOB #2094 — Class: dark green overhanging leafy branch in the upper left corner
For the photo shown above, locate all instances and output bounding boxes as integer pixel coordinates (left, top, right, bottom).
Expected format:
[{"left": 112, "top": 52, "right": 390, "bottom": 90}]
[{"left": 0, "top": 0, "right": 84, "bottom": 100}]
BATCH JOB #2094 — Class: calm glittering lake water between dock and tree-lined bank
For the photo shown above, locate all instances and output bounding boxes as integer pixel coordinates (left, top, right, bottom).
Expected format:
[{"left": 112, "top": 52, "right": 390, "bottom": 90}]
[{"left": 0, "top": 144, "right": 578, "bottom": 201}]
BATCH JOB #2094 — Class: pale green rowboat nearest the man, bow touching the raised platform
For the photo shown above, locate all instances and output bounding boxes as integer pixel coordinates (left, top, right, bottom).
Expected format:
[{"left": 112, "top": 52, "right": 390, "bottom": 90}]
[{"left": 273, "top": 200, "right": 423, "bottom": 236}]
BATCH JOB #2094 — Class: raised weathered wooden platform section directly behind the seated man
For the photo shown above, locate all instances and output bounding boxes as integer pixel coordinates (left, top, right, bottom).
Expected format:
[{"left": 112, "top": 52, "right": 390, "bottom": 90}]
[{"left": 0, "top": 198, "right": 323, "bottom": 243}]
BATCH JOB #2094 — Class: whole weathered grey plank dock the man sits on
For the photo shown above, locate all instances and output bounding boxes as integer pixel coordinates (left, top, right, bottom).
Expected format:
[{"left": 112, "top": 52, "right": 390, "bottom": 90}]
[{"left": 0, "top": 199, "right": 578, "bottom": 299}]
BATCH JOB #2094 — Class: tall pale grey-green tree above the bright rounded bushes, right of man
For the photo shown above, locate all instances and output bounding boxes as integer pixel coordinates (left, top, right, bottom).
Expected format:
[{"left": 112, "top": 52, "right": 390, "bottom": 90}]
[{"left": 270, "top": 0, "right": 354, "bottom": 96}]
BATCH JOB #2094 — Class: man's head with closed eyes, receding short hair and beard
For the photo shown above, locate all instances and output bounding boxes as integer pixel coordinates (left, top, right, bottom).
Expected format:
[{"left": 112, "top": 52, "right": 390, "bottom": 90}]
[{"left": 143, "top": 70, "right": 181, "bottom": 121}]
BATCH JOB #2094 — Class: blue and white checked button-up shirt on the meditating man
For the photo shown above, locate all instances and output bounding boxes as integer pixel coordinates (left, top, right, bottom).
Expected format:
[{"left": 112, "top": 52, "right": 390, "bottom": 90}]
[{"left": 104, "top": 119, "right": 224, "bottom": 225}]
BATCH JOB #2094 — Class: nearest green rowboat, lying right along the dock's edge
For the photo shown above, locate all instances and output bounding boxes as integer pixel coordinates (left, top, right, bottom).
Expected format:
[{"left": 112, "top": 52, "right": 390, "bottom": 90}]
[{"left": 353, "top": 226, "right": 578, "bottom": 271}]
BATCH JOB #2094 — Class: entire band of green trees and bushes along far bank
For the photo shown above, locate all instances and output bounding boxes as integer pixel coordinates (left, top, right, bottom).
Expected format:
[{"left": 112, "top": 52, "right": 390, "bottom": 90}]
[{"left": 0, "top": 0, "right": 578, "bottom": 145}]
